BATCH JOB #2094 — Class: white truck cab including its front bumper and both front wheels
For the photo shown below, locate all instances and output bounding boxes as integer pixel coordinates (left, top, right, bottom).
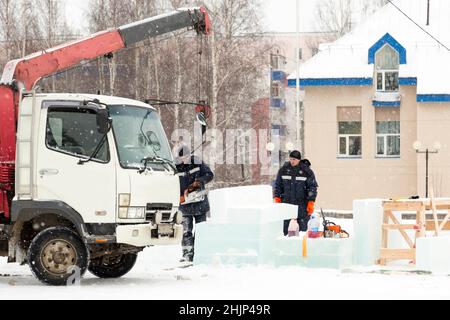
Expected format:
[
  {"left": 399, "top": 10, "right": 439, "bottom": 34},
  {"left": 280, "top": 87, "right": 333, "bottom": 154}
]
[{"left": 9, "top": 92, "right": 182, "bottom": 284}]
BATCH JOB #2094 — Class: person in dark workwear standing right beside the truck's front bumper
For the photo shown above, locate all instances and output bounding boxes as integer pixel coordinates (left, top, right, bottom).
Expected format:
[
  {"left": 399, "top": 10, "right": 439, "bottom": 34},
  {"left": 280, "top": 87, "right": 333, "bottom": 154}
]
[{"left": 176, "top": 144, "right": 214, "bottom": 262}]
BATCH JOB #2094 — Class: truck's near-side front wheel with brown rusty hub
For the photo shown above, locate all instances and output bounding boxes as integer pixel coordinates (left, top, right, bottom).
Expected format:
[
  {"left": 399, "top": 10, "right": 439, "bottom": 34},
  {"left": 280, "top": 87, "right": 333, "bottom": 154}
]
[{"left": 27, "top": 227, "right": 89, "bottom": 286}]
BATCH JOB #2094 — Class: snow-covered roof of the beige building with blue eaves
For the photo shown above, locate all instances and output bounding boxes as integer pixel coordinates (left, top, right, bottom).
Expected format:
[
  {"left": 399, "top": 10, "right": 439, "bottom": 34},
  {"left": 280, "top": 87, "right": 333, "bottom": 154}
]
[{"left": 288, "top": 0, "right": 450, "bottom": 95}]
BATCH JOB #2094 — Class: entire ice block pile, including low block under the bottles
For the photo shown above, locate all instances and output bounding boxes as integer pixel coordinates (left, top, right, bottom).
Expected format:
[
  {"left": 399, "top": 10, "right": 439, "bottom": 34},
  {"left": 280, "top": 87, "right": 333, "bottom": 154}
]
[{"left": 194, "top": 186, "right": 352, "bottom": 268}]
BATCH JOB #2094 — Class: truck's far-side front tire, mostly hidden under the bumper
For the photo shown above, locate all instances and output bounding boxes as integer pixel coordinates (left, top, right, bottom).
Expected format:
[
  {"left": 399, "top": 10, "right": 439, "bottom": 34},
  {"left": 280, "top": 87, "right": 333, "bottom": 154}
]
[{"left": 88, "top": 253, "right": 137, "bottom": 278}]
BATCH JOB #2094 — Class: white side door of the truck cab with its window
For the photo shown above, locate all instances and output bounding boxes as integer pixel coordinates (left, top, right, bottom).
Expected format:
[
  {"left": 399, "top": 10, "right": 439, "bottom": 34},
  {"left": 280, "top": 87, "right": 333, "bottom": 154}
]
[{"left": 36, "top": 102, "right": 116, "bottom": 223}]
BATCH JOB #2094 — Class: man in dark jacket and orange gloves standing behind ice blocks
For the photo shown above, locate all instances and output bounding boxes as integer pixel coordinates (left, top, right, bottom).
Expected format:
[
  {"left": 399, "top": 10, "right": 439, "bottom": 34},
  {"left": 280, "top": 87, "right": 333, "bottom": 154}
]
[{"left": 274, "top": 150, "right": 318, "bottom": 235}]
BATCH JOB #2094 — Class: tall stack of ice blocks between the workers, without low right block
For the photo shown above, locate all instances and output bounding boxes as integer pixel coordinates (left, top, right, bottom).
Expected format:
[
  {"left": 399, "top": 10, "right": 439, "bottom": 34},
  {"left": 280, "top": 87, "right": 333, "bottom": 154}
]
[{"left": 194, "top": 186, "right": 297, "bottom": 266}]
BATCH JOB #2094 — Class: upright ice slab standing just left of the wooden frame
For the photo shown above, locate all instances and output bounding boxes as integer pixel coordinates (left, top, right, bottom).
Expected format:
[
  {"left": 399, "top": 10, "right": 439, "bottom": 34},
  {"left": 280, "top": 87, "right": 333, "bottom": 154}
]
[{"left": 353, "top": 199, "right": 383, "bottom": 266}]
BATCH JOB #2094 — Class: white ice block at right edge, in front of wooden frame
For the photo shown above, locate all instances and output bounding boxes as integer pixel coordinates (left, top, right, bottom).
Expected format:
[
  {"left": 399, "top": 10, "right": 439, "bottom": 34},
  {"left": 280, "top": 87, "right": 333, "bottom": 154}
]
[{"left": 416, "top": 236, "right": 450, "bottom": 275}]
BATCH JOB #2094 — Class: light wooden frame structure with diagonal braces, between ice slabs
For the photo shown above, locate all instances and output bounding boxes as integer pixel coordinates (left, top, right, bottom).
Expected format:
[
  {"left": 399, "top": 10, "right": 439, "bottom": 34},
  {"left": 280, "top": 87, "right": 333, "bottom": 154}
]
[{"left": 378, "top": 198, "right": 450, "bottom": 265}]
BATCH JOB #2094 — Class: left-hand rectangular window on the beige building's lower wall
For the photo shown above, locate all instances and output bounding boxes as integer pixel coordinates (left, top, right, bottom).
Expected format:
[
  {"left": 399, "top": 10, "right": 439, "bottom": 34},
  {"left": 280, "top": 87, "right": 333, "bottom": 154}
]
[{"left": 338, "top": 107, "right": 362, "bottom": 158}]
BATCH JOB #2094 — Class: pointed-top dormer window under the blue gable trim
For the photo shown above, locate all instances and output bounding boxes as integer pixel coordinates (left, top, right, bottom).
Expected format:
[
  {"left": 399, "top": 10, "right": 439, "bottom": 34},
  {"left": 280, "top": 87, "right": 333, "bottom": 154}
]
[{"left": 375, "top": 44, "right": 400, "bottom": 92}]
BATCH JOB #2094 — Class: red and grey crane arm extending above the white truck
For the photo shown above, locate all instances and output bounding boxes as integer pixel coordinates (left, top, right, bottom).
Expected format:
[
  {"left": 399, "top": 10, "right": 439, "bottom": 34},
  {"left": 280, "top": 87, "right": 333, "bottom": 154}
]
[{"left": 0, "top": 7, "right": 211, "bottom": 90}]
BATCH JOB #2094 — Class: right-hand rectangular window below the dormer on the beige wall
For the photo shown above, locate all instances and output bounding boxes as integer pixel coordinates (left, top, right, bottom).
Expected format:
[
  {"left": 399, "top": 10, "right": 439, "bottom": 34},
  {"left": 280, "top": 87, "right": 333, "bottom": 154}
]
[{"left": 375, "top": 108, "right": 400, "bottom": 157}]
